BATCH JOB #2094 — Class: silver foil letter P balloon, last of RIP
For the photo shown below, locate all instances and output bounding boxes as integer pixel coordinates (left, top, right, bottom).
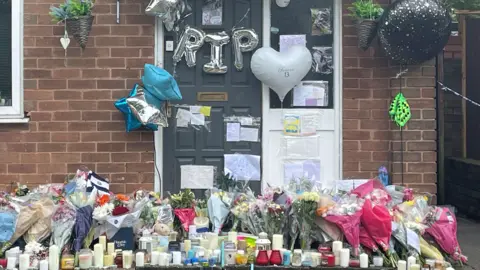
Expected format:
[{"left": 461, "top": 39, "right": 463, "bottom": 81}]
[{"left": 232, "top": 29, "right": 258, "bottom": 71}]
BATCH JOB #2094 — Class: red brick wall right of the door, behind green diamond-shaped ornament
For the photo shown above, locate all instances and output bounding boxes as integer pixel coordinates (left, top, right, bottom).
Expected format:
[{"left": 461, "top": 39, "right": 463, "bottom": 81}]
[{"left": 343, "top": 1, "right": 437, "bottom": 197}]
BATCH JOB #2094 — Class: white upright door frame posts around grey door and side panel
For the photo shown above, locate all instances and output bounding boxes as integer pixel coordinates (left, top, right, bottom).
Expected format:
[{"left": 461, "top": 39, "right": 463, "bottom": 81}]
[{"left": 154, "top": 0, "right": 343, "bottom": 197}]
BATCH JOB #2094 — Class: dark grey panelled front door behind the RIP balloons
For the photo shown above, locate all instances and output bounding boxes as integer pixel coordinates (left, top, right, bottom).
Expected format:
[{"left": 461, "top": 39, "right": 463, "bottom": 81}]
[{"left": 163, "top": 0, "right": 262, "bottom": 194}]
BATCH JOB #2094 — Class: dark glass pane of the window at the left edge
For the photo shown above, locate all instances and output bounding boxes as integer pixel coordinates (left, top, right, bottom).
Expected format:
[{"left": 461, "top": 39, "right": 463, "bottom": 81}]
[{"left": 0, "top": 0, "right": 12, "bottom": 106}]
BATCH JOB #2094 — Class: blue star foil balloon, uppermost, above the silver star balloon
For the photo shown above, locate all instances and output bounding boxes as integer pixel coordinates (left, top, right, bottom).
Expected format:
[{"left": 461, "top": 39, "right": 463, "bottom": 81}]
[{"left": 142, "top": 64, "right": 182, "bottom": 100}]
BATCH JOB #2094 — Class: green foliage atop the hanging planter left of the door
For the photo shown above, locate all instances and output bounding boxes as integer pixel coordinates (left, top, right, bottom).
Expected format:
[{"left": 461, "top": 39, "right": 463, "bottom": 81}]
[{"left": 49, "top": 0, "right": 94, "bottom": 22}]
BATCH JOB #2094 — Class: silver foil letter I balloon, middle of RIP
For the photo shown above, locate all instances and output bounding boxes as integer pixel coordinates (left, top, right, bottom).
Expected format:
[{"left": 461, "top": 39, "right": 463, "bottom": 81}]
[{"left": 203, "top": 32, "right": 230, "bottom": 74}]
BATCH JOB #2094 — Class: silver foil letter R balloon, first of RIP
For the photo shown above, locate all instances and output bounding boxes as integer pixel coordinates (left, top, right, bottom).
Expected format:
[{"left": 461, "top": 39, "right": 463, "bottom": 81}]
[{"left": 173, "top": 25, "right": 205, "bottom": 67}]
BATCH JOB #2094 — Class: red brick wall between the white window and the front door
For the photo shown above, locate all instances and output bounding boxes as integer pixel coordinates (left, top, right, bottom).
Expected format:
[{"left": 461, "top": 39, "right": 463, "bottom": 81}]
[{"left": 0, "top": 0, "right": 155, "bottom": 192}]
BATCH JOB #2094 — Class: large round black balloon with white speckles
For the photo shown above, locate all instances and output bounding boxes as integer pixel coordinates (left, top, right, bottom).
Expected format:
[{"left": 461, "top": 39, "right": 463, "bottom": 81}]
[{"left": 378, "top": 0, "right": 452, "bottom": 65}]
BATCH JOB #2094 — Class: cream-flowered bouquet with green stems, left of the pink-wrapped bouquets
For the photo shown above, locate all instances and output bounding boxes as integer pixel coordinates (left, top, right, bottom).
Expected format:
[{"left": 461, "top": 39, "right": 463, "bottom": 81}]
[{"left": 292, "top": 192, "right": 320, "bottom": 249}]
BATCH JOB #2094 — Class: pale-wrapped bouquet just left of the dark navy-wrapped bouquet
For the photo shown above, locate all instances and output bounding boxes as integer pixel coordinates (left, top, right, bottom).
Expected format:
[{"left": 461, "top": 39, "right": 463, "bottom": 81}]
[{"left": 50, "top": 202, "right": 77, "bottom": 254}]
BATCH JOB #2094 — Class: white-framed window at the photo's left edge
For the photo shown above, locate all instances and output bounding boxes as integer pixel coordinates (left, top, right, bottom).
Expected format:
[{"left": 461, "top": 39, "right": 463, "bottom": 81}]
[{"left": 0, "top": 0, "right": 24, "bottom": 122}]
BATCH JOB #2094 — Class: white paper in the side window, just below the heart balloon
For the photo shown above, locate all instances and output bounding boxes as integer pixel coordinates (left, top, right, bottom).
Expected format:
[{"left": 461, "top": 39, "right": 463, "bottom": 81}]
[{"left": 292, "top": 81, "right": 328, "bottom": 107}]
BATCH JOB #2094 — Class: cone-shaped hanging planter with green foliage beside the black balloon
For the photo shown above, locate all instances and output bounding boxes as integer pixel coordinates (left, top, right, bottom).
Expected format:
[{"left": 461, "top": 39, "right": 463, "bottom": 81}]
[{"left": 348, "top": 0, "right": 383, "bottom": 50}]
